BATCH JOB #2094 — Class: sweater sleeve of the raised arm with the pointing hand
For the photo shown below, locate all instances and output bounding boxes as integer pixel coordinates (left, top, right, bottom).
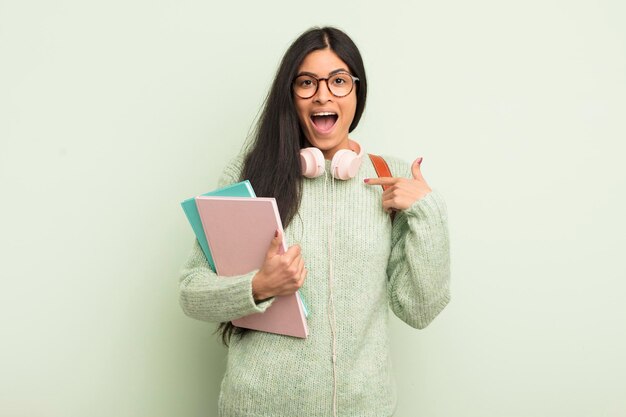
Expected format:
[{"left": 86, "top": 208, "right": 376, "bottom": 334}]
[{"left": 387, "top": 159, "right": 450, "bottom": 329}]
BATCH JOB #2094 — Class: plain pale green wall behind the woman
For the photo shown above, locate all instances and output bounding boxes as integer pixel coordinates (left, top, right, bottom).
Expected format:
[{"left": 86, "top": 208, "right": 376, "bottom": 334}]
[{"left": 0, "top": 0, "right": 626, "bottom": 417}]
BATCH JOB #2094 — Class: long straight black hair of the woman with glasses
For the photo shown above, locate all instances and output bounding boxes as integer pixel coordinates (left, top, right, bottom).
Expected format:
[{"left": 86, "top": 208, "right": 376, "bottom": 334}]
[{"left": 217, "top": 27, "right": 367, "bottom": 345}]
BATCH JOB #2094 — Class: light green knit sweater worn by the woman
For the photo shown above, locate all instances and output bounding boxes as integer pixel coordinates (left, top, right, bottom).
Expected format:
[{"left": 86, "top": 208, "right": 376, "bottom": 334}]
[{"left": 180, "top": 153, "right": 450, "bottom": 417}]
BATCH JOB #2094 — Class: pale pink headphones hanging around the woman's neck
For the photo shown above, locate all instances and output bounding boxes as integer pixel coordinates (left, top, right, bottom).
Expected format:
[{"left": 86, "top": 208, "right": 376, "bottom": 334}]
[{"left": 300, "top": 140, "right": 363, "bottom": 180}]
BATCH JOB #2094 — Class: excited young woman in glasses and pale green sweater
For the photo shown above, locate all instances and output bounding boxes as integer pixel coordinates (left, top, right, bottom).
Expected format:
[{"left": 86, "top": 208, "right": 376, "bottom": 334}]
[{"left": 180, "top": 27, "right": 450, "bottom": 417}]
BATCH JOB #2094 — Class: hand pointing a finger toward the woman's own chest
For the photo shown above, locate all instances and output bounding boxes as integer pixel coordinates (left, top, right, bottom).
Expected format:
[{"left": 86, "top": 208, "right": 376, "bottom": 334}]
[{"left": 365, "top": 158, "right": 432, "bottom": 213}]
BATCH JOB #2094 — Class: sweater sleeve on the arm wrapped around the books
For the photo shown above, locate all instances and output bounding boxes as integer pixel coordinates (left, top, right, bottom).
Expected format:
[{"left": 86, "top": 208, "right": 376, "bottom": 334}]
[{"left": 179, "top": 158, "right": 274, "bottom": 322}]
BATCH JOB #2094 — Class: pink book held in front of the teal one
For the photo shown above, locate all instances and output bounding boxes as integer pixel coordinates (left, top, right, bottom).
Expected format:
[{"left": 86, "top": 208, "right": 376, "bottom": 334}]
[{"left": 196, "top": 196, "right": 309, "bottom": 338}]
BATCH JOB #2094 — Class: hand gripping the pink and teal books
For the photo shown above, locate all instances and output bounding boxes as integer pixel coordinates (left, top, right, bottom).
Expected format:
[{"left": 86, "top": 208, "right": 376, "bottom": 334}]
[{"left": 252, "top": 231, "right": 307, "bottom": 301}]
